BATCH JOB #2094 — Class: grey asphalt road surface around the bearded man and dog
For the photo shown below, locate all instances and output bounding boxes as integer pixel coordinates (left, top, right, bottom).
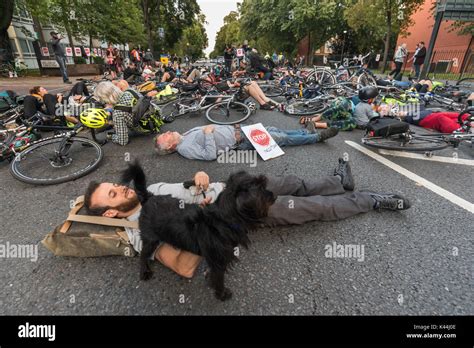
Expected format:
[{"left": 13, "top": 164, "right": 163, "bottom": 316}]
[{"left": 0, "top": 77, "right": 474, "bottom": 315}]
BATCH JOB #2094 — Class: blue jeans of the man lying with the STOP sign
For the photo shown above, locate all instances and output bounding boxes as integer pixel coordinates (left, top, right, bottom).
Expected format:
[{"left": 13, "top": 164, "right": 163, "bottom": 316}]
[{"left": 237, "top": 127, "right": 320, "bottom": 150}]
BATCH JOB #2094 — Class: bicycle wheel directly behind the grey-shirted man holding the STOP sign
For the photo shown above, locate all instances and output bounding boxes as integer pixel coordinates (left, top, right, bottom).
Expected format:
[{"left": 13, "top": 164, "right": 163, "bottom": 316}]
[{"left": 206, "top": 101, "right": 251, "bottom": 125}]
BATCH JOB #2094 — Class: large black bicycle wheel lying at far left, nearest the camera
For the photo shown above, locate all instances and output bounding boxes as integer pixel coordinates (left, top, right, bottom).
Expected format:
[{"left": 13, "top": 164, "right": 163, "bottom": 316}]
[{"left": 10, "top": 137, "right": 103, "bottom": 185}]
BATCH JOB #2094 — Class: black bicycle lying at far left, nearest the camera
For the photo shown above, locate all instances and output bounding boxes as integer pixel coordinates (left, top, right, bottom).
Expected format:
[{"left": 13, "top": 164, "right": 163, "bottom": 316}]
[{"left": 4, "top": 117, "right": 105, "bottom": 185}]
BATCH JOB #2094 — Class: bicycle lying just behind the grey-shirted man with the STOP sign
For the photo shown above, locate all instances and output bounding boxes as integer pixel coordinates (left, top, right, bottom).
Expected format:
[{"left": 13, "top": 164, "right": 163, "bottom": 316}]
[{"left": 158, "top": 81, "right": 252, "bottom": 125}]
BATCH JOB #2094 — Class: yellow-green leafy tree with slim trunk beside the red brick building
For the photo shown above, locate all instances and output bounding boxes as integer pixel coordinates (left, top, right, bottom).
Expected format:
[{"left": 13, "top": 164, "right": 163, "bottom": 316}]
[{"left": 344, "top": 0, "right": 425, "bottom": 73}]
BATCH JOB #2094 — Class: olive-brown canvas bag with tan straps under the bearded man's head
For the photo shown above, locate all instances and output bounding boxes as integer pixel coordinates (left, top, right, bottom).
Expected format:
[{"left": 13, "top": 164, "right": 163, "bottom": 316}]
[{"left": 41, "top": 196, "right": 138, "bottom": 257}]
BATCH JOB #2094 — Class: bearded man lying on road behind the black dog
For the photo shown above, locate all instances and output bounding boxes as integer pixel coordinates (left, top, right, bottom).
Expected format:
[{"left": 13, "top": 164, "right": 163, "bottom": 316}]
[{"left": 84, "top": 158, "right": 410, "bottom": 278}]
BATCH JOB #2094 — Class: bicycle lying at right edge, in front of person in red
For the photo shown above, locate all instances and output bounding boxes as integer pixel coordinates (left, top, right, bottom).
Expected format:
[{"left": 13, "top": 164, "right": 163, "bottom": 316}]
[{"left": 362, "top": 106, "right": 474, "bottom": 156}]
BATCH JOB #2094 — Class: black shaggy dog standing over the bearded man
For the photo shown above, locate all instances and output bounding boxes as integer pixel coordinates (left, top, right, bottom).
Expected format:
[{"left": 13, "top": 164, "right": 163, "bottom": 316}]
[{"left": 122, "top": 163, "right": 275, "bottom": 301}]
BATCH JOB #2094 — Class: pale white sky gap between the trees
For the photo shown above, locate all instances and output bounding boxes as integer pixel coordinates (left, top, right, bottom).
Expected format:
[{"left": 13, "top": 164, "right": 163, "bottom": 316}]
[{"left": 197, "top": 0, "right": 242, "bottom": 54}]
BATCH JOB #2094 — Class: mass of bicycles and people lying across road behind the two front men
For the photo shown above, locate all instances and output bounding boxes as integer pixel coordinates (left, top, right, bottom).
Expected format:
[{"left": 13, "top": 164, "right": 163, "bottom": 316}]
[{"left": 0, "top": 52, "right": 474, "bottom": 184}]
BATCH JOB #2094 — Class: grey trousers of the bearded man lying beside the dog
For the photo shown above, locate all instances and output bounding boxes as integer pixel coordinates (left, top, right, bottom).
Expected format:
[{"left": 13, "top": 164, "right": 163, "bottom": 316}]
[{"left": 265, "top": 175, "right": 374, "bottom": 226}]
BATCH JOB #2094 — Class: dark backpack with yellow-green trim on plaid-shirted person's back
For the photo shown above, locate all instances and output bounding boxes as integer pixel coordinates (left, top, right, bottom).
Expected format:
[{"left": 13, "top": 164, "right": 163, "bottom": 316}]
[{"left": 114, "top": 89, "right": 163, "bottom": 134}]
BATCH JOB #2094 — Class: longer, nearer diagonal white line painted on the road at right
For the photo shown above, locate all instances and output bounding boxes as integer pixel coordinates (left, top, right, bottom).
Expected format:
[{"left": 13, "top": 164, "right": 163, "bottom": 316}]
[{"left": 345, "top": 140, "right": 474, "bottom": 214}]
